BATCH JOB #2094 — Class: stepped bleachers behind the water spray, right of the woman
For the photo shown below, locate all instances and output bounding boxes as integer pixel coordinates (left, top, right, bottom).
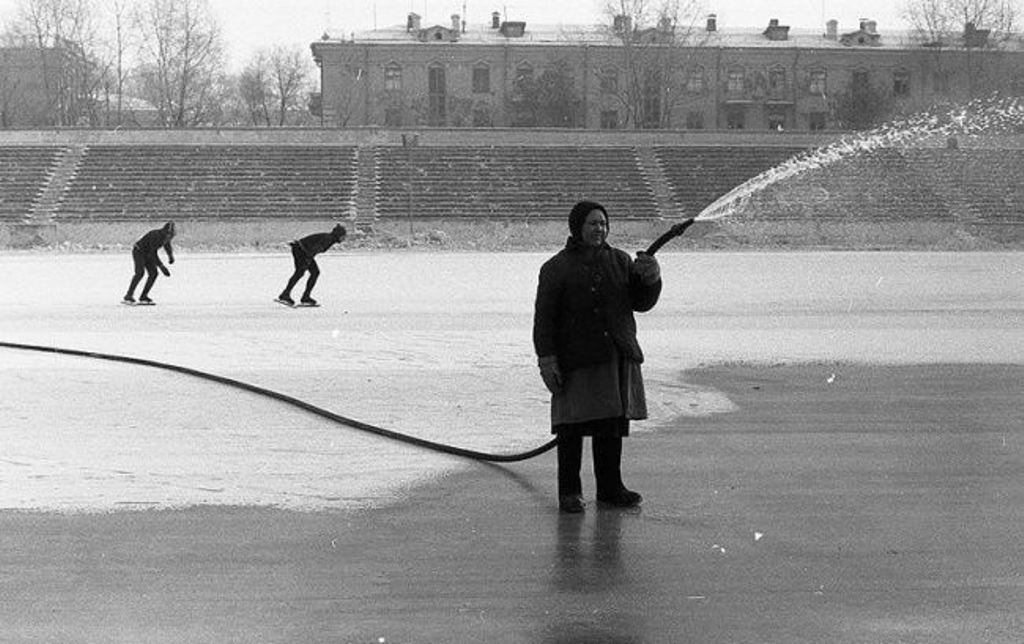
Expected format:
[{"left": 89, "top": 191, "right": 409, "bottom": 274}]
[{"left": 656, "top": 146, "right": 1024, "bottom": 224}]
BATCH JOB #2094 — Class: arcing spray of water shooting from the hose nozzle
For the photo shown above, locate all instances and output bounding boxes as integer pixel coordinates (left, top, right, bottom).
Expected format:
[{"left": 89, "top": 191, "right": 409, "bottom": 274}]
[{"left": 696, "top": 91, "right": 1024, "bottom": 221}]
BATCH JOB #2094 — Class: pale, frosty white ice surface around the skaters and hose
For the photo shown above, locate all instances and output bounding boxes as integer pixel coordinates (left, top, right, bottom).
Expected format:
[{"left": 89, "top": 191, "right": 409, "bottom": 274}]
[{"left": 0, "top": 252, "right": 1024, "bottom": 511}]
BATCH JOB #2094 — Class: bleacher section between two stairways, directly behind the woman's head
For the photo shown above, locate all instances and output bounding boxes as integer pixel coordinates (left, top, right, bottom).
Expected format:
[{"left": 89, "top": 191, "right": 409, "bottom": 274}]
[{"left": 376, "top": 145, "right": 658, "bottom": 219}]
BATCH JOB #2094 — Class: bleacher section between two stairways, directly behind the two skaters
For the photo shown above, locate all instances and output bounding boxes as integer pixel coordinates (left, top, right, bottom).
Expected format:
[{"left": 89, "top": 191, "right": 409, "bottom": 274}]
[{"left": 53, "top": 145, "right": 355, "bottom": 221}]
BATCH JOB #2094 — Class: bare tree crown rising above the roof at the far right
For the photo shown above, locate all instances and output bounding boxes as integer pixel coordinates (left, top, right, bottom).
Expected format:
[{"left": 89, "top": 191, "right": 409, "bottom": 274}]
[{"left": 901, "top": 0, "right": 1021, "bottom": 46}]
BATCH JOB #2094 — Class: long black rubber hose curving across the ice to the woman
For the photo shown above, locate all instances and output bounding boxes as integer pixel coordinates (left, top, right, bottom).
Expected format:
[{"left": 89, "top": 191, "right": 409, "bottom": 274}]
[{"left": 0, "top": 341, "right": 558, "bottom": 463}]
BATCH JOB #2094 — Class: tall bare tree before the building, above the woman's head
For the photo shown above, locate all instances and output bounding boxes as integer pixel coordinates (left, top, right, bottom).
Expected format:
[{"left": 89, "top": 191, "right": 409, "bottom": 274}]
[{"left": 596, "top": 0, "right": 702, "bottom": 129}]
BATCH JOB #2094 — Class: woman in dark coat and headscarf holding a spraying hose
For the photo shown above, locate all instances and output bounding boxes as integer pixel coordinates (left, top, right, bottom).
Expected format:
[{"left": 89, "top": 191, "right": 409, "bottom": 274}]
[{"left": 534, "top": 201, "right": 662, "bottom": 513}]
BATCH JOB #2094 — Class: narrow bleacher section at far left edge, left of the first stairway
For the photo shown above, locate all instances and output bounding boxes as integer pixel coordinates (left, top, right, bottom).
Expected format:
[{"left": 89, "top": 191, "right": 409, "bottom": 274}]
[{"left": 0, "top": 145, "right": 63, "bottom": 222}]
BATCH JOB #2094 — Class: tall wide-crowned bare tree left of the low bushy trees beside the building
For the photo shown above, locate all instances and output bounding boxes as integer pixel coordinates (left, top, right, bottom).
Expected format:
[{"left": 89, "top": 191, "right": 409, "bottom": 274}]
[{"left": 138, "top": 0, "right": 225, "bottom": 128}]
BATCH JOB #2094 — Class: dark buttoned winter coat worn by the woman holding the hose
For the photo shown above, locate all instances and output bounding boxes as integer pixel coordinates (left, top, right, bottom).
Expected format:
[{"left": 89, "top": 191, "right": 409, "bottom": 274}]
[{"left": 534, "top": 238, "right": 662, "bottom": 372}]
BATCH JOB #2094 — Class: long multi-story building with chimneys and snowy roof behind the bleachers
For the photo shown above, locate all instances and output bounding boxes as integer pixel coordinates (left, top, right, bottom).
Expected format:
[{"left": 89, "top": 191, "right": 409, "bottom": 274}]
[{"left": 311, "top": 12, "right": 1024, "bottom": 130}]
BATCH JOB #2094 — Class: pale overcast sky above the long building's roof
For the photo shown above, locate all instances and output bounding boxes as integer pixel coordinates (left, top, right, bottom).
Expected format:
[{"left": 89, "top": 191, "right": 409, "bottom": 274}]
[{"left": 0, "top": 0, "right": 905, "bottom": 69}]
